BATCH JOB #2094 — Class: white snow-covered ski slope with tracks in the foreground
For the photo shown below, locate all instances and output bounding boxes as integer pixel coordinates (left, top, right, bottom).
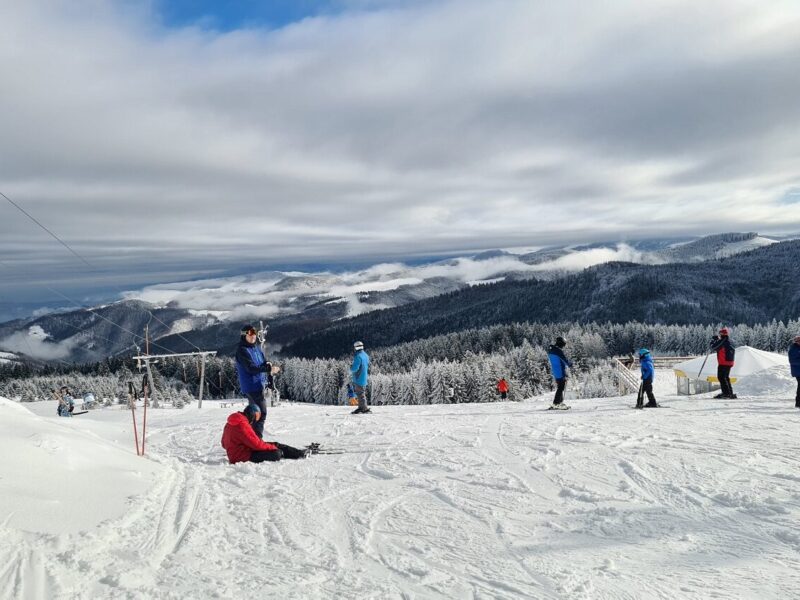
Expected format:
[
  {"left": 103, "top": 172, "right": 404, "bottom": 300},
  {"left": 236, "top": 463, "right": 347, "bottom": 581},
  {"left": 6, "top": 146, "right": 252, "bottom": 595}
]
[{"left": 0, "top": 377, "right": 800, "bottom": 600}]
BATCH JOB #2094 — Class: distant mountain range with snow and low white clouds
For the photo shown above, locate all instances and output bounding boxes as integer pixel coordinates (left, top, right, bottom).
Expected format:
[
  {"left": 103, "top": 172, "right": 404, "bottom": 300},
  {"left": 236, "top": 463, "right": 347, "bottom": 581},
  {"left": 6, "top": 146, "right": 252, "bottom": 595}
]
[{"left": 0, "top": 233, "right": 788, "bottom": 361}]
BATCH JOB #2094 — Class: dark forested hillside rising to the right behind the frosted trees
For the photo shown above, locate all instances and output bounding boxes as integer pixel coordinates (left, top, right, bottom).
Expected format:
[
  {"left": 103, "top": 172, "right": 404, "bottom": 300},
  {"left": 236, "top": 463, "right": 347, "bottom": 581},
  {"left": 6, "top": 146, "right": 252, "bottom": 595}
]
[{"left": 284, "top": 241, "right": 800, "bottom": 357}]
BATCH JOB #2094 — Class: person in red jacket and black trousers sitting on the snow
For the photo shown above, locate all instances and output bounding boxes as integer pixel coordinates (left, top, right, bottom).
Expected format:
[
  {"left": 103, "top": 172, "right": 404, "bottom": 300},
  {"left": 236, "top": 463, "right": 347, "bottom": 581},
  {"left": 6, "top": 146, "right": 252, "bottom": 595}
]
[{"left": 222, "top": 404, "right": 310, "bottom": 464}]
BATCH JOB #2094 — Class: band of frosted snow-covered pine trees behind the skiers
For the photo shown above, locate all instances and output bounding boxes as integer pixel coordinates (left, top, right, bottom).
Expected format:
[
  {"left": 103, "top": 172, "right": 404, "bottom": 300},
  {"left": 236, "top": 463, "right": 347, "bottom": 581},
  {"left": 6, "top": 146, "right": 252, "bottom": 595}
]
[{"left": 0, "top": 321, "right": 800, "bottom": 407}]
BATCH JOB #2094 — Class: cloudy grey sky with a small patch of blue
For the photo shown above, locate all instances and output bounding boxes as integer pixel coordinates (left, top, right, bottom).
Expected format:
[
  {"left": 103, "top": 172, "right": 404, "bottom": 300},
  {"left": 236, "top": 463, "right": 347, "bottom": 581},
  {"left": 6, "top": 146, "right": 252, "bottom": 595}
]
[{"left": 0, "top": 0, "right": 800, "bottom": 316}]
